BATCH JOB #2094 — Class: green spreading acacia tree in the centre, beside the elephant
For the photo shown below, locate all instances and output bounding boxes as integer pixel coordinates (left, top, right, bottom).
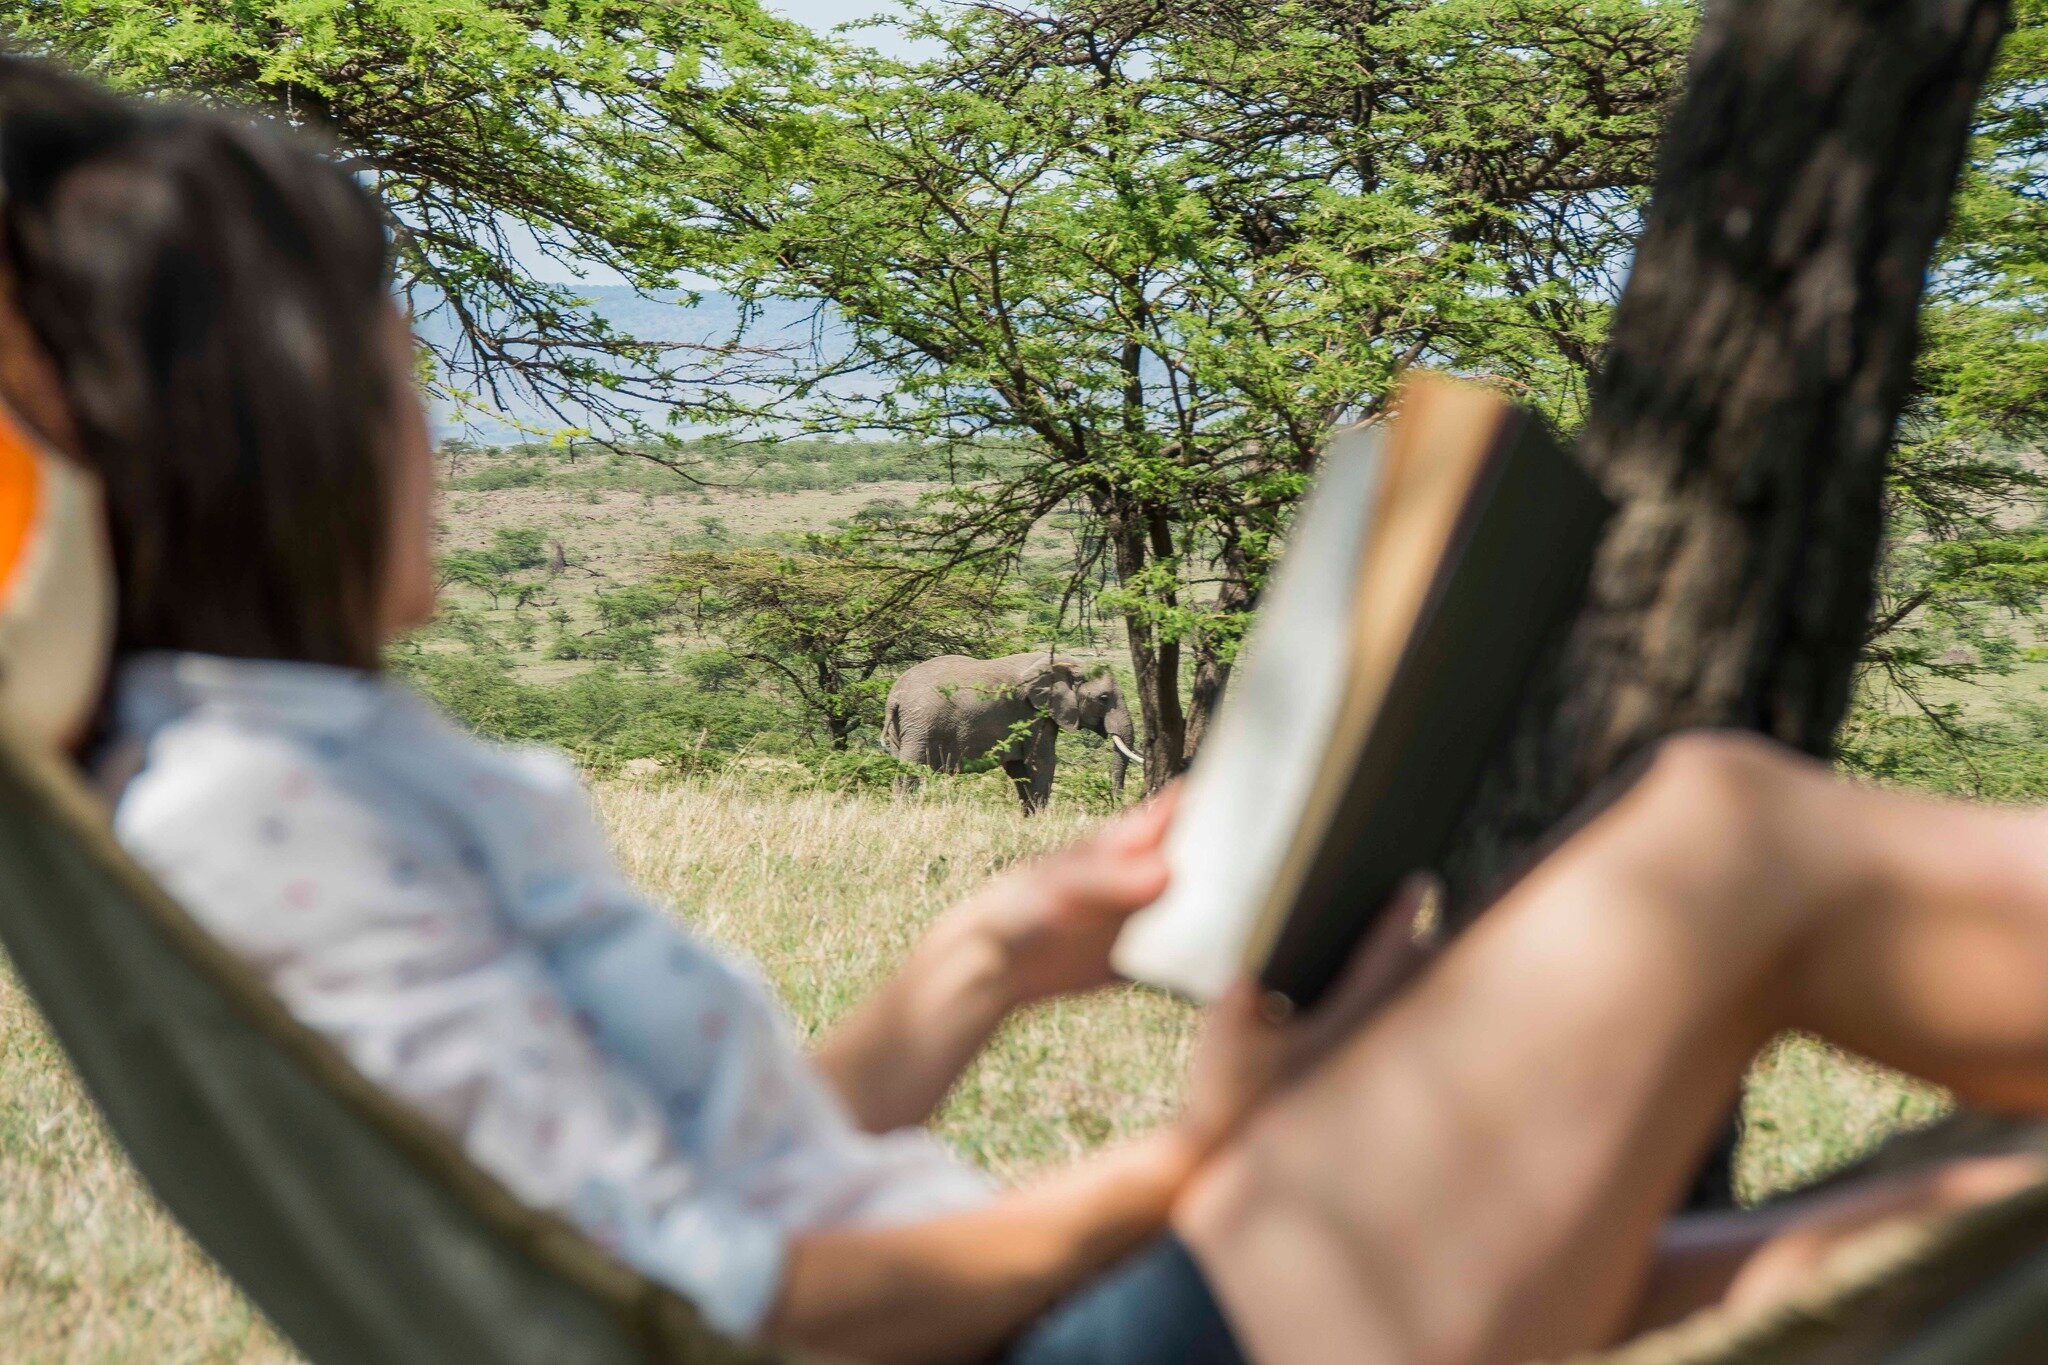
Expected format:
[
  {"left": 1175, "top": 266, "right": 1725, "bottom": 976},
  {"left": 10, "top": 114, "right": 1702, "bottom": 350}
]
[{"left": 690, "top": 0, "right": 1692, "bottom": 784}]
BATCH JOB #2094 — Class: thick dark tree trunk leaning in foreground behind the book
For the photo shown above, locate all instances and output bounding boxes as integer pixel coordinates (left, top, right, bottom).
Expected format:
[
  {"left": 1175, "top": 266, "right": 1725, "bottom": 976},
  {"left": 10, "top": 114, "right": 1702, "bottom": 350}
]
[{"left": 1446, "top": 0, "right": 2005, "bottom": 1203}]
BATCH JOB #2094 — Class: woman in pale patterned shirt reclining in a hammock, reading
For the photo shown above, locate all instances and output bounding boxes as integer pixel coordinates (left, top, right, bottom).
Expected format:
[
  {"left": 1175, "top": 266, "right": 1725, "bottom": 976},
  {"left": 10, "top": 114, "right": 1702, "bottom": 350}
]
[{"left": 12, "top": 50, "right": 2048, "bottom": 1365}]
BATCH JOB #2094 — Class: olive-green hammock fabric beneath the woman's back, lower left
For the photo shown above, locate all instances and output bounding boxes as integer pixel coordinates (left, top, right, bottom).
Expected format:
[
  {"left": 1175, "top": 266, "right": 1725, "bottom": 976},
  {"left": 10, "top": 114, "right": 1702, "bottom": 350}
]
[{"left": 0, "top": 741, "right": 776, "bottom": 1365}]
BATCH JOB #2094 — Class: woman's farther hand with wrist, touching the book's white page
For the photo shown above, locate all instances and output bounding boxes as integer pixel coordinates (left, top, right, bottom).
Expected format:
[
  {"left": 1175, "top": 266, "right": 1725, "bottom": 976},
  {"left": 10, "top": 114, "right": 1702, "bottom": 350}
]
[{"left": 950, "top": 788, "right": 1176, "bottom": 1009}]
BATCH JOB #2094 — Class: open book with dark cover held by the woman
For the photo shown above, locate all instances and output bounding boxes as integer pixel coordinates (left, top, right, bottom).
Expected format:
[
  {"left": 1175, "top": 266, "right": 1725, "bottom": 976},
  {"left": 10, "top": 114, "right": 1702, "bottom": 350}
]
[{"left": 1114, "top": 377, "right": 1610, "bottom": 1005}]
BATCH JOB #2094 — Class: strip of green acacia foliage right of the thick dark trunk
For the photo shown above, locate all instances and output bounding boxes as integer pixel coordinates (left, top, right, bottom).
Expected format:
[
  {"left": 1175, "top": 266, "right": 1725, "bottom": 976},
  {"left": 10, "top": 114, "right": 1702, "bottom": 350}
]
[{"left": 1841, "top": 0, "right": 2048, "bottom": 786}]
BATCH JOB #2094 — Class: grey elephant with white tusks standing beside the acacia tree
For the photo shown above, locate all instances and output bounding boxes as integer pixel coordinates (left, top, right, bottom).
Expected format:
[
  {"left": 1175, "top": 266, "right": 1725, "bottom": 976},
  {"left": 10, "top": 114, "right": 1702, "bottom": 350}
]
[{"left": 883, "top": 651, "right": 1145, "bottom": 814}]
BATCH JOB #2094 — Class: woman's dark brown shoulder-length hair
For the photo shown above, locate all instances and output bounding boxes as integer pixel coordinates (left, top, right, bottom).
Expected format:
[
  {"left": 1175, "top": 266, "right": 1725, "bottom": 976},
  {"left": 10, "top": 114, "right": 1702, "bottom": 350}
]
[{"left": 0, "top": 55, "right": 393, "bottom": 667}]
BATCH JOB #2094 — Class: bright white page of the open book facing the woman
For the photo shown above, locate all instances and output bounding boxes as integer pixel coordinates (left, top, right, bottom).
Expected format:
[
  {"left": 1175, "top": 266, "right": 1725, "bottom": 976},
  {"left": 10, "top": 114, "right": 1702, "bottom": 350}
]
[{"left": 1110, "top": 428, "right": 1382, "bottom": 1001}]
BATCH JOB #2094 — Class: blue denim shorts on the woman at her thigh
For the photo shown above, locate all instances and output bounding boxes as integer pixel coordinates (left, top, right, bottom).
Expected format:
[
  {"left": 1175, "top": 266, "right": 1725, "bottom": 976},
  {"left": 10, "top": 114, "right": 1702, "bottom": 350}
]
[{"left": 1006, "top": 1236, "right": 1245, "bottom": 1365}]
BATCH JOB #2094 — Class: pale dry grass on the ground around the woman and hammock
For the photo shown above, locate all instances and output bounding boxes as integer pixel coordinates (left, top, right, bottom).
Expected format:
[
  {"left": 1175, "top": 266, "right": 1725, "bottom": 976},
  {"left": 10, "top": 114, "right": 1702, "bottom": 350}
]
[{"left": 0, "top": 778, "right": 1942, "bottom": 1365}]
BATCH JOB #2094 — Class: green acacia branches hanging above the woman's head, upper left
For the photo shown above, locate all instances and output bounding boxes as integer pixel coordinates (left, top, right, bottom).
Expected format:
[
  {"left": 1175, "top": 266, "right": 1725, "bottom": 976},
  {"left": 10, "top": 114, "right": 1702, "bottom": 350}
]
[{"left": 0, "top": 0, "right": 809, "bottom": 448}]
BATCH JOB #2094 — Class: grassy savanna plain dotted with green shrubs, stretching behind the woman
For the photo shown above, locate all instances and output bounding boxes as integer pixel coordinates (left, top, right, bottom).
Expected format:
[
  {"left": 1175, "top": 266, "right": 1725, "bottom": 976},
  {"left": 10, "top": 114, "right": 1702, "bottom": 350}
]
[{"left": 0, "top": 450, "right": 1982, "bottom": 1365}]
